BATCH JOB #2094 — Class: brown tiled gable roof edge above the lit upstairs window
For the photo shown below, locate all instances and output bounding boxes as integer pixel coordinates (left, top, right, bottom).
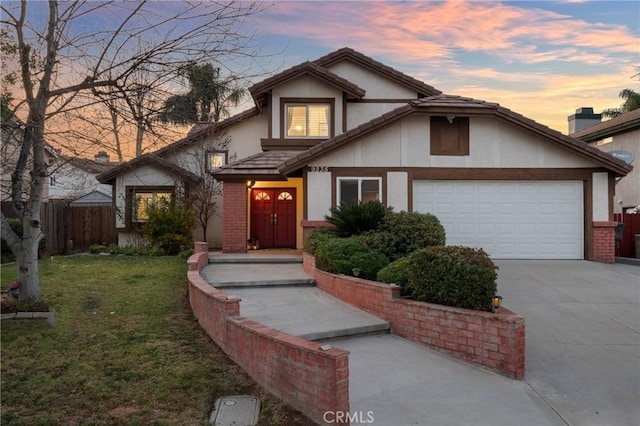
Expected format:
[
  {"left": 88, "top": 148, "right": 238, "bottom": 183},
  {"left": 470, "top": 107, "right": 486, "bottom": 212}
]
[{"left": 249, "top": 62, "right": 365, "bottom": 105}]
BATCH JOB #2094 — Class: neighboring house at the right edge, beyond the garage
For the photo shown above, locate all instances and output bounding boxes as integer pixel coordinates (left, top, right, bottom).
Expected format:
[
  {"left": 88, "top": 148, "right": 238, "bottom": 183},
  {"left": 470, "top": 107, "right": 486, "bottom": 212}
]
[{"left": 570, "top": 108, "right": 640, "bottom": 213}]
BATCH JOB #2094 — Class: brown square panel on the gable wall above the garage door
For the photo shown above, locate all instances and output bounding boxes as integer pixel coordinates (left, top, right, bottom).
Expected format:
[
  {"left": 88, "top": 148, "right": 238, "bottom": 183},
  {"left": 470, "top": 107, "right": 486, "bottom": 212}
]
[{"left": 430, "top": 115, "right": 469, "bottom": 156}]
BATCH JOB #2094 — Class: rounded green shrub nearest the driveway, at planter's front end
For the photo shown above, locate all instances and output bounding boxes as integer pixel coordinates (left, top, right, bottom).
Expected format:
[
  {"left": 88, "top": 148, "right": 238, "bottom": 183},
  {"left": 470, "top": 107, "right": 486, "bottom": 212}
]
[{"left": 408, "top": 246, "right": 498, "bottom": 311}]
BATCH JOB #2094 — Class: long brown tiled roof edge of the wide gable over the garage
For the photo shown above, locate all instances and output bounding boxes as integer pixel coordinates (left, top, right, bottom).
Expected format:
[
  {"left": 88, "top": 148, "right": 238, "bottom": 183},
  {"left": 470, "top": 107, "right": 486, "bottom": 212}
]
[{"left": 278, "top": 95, "right": 632, "bottom": 176}]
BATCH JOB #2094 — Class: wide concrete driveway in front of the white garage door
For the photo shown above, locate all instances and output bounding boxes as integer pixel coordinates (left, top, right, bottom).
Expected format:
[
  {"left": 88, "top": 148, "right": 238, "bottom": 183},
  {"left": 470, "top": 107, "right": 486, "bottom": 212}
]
[{"left": 495, "top": 260, "right": 640, "bottom": 426}]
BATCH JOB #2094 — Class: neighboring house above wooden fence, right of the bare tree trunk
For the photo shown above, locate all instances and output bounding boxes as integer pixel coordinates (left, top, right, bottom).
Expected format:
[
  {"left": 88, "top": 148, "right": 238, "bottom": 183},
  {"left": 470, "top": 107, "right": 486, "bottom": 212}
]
[{"left": 49, "top": 151, "right": 117, "bottom": 203}]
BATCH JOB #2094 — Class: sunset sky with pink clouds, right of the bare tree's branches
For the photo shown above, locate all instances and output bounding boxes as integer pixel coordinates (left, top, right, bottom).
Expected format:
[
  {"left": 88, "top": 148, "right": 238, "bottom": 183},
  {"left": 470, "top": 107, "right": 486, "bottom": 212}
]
[{"left": 242, "top": 0, "right": 640, "bottom": 133}]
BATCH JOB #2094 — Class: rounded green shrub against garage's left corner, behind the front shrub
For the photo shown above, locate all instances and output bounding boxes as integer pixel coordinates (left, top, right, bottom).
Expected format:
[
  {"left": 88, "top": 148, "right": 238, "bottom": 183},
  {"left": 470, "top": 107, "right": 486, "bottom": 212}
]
[{"left": 363, "top": 212, "right": 445, "bottom": 261}]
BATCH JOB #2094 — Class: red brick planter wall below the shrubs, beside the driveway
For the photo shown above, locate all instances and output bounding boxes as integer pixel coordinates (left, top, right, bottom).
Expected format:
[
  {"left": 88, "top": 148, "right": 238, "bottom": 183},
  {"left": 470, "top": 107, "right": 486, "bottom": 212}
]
[{"left": 303, "top": 253, "right": 525, "bottom": 379}]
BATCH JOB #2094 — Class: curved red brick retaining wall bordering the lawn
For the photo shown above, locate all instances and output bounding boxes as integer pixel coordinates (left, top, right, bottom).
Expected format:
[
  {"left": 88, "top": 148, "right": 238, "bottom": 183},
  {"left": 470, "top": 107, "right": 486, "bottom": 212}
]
[{"left": 187, "top": 251, "right": 349, "bottom": 424}]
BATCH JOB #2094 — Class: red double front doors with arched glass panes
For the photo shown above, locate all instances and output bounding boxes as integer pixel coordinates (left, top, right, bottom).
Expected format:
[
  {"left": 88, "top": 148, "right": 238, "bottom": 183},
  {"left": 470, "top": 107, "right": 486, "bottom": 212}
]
[{"left": 251, "top": 188, "right": 296, "bottom": 248}]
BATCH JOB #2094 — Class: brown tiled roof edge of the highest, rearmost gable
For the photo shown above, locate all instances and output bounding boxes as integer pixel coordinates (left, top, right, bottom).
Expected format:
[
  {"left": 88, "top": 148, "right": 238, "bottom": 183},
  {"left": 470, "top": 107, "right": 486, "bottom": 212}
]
[{"left": 313, "top": 47, "right": 442, "bottom": 97}]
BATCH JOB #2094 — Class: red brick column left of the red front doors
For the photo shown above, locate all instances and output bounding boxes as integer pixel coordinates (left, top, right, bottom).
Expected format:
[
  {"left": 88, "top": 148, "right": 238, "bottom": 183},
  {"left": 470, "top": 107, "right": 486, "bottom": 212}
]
[{"left": 222, "top": 181, "right": 248, "bottom": 253}]
